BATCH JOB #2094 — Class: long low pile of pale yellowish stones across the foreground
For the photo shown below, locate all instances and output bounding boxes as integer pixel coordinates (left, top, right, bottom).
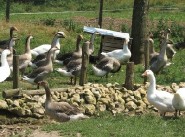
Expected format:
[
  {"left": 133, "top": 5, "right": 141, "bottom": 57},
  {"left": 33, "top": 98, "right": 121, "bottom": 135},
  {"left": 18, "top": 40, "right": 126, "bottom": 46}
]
[{"left": 0, "top": 83, "right": 185, "bottom": 118}]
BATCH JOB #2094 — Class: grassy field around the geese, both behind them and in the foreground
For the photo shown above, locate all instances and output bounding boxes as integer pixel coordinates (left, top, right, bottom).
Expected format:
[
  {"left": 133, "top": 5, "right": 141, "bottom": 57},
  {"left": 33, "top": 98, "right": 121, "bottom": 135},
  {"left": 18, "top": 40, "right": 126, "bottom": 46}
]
[{"left": 0, "top": 1, "right": 185, "bottom": 137}]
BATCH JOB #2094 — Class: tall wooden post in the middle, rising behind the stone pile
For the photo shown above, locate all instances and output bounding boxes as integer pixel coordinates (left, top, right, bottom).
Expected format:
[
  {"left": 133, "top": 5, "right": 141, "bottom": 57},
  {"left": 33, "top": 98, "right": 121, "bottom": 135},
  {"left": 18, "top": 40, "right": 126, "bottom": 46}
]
[{"left": 79, "top": 41, "right": 90, "bottom": 86}]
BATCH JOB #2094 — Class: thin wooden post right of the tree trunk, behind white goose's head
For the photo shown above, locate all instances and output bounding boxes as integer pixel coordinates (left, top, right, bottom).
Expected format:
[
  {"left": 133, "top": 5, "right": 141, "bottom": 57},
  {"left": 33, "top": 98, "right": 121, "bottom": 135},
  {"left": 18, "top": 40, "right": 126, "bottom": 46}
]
[{"left": 144, "top": 39, "right": 149, "bottom": 84}]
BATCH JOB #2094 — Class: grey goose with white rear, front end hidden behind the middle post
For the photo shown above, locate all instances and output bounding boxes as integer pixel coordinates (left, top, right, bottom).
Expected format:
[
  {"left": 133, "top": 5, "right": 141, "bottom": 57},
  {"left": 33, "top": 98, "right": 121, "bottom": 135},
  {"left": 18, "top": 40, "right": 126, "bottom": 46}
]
[{"left": 55, "top": 58, "right": 82, "bottom": 85}]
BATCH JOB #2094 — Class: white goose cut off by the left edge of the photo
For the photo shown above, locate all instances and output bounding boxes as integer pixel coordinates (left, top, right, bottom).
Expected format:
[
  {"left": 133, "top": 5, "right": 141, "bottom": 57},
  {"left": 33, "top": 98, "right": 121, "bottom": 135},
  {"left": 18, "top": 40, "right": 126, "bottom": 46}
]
[{"left": 0, "top": 49, "right": 11, "bottom": 82}]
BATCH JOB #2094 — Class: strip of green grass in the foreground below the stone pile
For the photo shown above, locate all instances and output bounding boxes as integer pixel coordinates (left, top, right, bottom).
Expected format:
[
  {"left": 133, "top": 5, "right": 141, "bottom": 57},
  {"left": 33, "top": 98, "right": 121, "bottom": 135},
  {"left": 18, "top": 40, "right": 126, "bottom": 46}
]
[{"left": 43, "top": 113, "right": 185, "bottom": 137}]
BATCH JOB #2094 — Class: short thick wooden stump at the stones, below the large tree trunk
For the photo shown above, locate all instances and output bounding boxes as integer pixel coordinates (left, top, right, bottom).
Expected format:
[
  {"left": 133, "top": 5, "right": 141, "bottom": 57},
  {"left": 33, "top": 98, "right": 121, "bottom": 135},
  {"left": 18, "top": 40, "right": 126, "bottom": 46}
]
[{"left": 125, "top": 62, "right": 134, "bottom": 90}]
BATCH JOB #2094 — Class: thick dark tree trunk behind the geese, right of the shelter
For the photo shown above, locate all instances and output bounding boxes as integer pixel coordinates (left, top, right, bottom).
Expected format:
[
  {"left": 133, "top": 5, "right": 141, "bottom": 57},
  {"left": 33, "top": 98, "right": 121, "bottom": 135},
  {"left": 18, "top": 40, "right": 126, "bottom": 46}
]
[{"left": 131, "top": 0, "right": 149, "bottom": 64}]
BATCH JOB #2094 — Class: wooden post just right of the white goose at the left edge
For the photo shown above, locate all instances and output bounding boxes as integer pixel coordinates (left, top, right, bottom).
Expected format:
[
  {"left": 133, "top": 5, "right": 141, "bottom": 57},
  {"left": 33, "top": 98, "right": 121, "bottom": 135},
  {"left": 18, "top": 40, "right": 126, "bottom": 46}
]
[{"left": 13, "top": 54, "right": 19, "bottom": 89}]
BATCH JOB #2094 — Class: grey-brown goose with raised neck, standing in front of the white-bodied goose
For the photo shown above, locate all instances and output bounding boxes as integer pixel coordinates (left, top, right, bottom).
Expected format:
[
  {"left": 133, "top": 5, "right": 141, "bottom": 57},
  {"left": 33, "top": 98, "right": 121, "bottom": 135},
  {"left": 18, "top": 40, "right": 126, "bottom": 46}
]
[{"left": 22, "top": 47, "right": 58, "bottom": 89}]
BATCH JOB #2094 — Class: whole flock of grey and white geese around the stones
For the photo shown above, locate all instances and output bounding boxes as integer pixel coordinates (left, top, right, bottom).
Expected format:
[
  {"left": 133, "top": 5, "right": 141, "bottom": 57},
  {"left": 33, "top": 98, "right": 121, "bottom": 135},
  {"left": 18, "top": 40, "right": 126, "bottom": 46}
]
[{"left": 0, "top": 27, "right": 185, "bottom": 122}]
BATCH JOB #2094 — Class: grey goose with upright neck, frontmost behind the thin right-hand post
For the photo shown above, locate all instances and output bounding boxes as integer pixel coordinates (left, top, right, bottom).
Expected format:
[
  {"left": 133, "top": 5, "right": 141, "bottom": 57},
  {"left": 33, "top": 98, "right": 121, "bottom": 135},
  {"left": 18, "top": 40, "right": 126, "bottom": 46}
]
[{"left": 149, "top": 30, "right": 170, "bottom": 74}]
